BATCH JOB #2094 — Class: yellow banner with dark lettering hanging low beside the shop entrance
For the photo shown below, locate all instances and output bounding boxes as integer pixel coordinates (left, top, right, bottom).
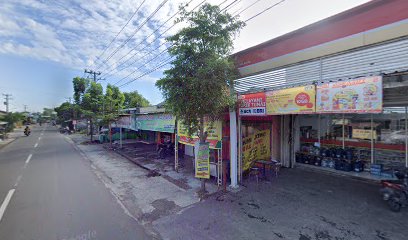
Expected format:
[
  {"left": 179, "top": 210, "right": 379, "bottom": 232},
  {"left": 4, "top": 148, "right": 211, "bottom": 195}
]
[{"left": 242, "top": 129, "right": 271, "bottom": 171}]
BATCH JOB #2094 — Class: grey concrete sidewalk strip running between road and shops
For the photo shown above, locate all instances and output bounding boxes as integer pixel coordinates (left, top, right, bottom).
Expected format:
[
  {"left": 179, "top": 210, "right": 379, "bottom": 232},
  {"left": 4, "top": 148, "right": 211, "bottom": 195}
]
[{"left": 66, "top": 134, "right": 220, "bottom": 238}]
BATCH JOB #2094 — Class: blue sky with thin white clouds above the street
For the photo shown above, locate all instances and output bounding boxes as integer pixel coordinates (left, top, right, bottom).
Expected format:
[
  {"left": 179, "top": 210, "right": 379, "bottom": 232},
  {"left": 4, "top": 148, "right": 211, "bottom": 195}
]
[{"left": 0, "top": 0, "right": 368, "bottom": 112}]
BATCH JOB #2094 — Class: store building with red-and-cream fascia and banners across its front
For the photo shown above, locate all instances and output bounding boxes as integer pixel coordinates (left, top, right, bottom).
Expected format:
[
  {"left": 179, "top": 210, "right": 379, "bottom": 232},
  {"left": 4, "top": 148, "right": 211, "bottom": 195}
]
[{"left": 231, "top": 0, "right": 408, "bottom": 184}]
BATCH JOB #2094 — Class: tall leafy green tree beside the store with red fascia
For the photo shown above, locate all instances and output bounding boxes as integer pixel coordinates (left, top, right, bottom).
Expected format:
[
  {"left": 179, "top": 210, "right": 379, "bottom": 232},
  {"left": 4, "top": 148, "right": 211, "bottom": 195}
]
[{"left": 156, "top": 4, "right": 244, "bottom": 191}]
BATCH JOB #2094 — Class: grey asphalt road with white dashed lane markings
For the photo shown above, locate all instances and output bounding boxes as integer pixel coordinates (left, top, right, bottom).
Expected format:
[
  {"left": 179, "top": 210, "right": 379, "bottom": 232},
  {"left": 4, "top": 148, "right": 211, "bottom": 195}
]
[{"left": 0, "top": 125, "right": 150, "bottom": 240}]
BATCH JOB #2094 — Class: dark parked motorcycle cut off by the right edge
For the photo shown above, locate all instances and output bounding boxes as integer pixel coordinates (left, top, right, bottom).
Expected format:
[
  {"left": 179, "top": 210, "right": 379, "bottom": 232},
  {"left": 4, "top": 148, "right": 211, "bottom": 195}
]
[{"left": 380, "top": 171, "right": 408, "bottom": 212}]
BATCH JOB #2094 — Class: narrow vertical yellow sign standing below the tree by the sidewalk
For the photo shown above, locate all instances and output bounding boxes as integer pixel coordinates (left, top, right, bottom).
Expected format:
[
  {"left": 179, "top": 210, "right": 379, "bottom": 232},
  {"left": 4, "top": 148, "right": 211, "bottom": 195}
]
[{"left": 194, "top": 142, "right": 210, "bottom": 179}]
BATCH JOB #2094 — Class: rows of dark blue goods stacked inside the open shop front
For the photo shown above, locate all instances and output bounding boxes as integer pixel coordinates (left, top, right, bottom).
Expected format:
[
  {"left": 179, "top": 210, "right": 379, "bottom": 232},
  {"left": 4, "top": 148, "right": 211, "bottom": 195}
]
[{"left": 296, "top": 147, "right": 364, "bottom": 172}]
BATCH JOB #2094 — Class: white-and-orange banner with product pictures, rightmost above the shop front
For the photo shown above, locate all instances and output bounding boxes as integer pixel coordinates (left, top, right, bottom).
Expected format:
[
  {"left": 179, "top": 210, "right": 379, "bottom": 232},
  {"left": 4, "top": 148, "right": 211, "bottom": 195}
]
[{"left": 316, "top": 76, "right": 383, "bottom": 113}]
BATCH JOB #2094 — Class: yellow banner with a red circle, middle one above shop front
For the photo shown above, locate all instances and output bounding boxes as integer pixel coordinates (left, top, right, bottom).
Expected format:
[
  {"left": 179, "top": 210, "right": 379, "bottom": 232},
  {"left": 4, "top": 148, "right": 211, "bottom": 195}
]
[{"left": 265, "top": 85, "right": 316, "bottom": 115}]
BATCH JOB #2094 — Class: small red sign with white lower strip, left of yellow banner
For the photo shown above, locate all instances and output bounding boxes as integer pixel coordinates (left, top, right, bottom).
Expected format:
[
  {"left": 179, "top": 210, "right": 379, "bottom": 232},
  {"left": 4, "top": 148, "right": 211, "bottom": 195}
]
[{"left": 238, "top": 92, "right": 266, "bottom": 116}]
